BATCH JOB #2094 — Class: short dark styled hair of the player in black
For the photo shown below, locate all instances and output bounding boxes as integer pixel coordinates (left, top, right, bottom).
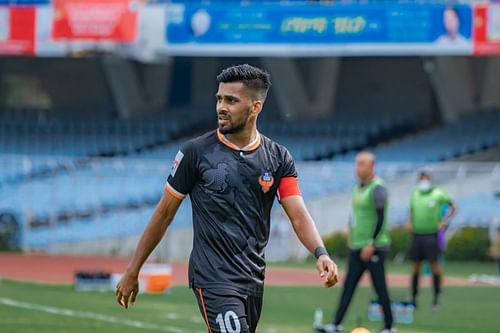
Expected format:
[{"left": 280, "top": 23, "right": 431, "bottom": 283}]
[{"left": 217, "top": 64, "right": 271, "bottom": 101}]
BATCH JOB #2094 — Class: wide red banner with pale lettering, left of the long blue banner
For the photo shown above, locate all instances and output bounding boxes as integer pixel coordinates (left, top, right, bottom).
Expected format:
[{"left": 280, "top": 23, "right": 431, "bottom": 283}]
[{"left": 52, "top": 0, "right": 139, "bottom": 43}]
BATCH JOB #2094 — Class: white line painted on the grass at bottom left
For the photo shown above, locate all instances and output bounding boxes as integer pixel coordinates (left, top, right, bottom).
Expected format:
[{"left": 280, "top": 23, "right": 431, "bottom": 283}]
[{"left": 0, "top": 297, "right": 203, "bottom": 333}]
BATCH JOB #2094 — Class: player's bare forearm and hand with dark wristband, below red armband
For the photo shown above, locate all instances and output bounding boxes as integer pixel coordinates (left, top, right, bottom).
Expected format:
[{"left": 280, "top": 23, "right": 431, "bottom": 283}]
[{"left": 281, "top": 194, "right": 338, "bottom": 287}]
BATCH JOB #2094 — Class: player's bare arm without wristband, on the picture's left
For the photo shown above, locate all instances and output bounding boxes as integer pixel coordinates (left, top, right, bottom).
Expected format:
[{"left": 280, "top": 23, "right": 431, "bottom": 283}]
[{"left": 116, "top": 190, "right": 182, "bottom": 309}]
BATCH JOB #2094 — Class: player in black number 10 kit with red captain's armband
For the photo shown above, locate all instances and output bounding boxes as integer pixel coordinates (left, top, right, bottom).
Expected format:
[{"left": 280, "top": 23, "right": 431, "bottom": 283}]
[{"left": 116, "top": 65, "right": 337, "bottom": 333}]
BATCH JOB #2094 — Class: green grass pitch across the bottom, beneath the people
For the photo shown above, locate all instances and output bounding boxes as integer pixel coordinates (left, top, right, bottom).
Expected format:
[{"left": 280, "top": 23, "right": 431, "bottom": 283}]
[{"left": 0, "top": 280, "right": 500, "bottom": 333}]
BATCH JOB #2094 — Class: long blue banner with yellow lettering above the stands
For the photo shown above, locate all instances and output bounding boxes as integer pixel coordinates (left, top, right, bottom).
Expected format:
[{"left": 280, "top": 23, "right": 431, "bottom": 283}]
[{"left": 166, "top": 3, "right": 472, "bottom": 54}]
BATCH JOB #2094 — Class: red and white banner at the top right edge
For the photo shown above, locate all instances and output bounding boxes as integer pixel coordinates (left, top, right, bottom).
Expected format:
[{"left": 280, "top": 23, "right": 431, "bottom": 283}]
[{"left": 474, "top": 4, "right": 500, "bottom": 55}]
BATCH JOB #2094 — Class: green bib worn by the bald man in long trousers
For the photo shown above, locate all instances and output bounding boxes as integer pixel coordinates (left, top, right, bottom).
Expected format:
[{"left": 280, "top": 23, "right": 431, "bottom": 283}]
[{"left": 350, "top": 178, "right": 391, "bottom": 249}]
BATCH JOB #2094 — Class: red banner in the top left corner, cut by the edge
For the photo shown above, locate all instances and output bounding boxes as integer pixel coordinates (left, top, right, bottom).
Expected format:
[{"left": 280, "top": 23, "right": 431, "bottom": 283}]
[{"left": 0, "top": 6, "right": 36, "bottom": 55}]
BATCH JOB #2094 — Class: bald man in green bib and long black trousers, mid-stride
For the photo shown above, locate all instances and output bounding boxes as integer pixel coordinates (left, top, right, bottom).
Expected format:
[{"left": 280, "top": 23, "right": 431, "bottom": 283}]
[{"left": 321, "top": 151, "right": 396, "bottom": 333}]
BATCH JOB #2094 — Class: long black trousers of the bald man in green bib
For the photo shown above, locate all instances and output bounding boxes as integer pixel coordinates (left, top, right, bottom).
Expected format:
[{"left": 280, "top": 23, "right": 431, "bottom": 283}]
[{"left": 334, "top": 249, "right": 393, "bottom": 328}]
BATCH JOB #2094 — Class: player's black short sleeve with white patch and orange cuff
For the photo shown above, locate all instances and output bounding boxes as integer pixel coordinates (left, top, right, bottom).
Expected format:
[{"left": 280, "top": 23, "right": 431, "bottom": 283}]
[{"left": 165, "top": 143, "right": 198, "bottom": 199}]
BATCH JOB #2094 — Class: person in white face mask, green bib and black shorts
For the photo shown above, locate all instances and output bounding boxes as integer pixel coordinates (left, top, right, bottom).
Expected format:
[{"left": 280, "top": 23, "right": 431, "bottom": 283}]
[{"left": 408, "top": 171, "right": 456, "bottom": 309}]
